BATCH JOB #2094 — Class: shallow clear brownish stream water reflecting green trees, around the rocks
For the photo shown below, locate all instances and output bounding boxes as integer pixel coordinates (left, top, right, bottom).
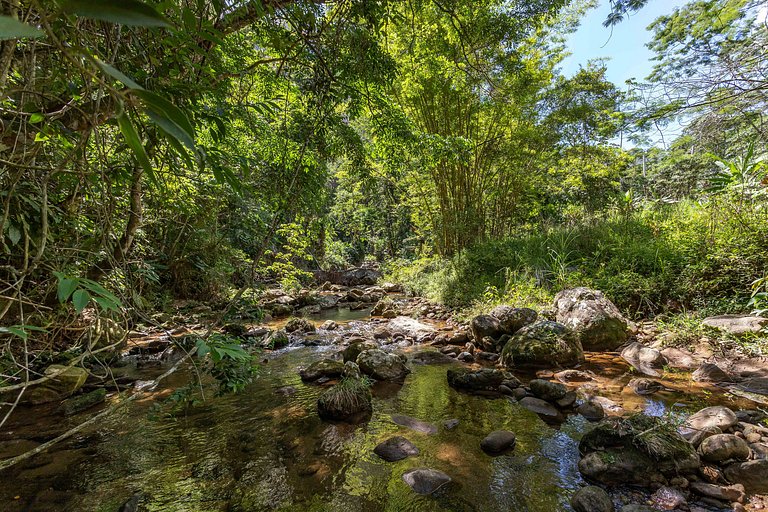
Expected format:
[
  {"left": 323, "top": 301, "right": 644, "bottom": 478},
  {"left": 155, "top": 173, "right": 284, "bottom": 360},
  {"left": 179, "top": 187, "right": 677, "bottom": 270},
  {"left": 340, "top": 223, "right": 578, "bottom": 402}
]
[{"left": 0, "top": 306, "right": 756, "bottom": 512}]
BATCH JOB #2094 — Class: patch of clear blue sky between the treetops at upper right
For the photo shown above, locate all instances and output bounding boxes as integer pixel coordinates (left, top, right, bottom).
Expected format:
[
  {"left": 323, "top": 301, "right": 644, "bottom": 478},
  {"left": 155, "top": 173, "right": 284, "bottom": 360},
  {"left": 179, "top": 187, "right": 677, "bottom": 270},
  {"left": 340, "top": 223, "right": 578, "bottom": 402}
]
[{"left": 561, "top": 0, "right": 687, "bottom": 88}]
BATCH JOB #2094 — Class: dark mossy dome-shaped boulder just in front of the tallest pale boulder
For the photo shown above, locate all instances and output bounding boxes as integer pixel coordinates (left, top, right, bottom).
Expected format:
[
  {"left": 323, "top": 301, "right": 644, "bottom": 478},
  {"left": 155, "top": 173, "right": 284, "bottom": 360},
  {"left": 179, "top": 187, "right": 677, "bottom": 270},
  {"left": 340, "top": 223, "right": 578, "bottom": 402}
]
[{"left": 501, "top": 320, "right": 584, "bottom": 368}]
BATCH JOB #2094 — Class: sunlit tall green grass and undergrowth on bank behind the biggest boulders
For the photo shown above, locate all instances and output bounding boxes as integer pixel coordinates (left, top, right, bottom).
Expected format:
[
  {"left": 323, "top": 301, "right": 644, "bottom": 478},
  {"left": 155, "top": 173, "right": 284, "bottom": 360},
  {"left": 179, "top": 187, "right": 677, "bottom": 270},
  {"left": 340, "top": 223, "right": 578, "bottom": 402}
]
[{"left": 388, "top": 202, "right": 768, "bottom": 317}]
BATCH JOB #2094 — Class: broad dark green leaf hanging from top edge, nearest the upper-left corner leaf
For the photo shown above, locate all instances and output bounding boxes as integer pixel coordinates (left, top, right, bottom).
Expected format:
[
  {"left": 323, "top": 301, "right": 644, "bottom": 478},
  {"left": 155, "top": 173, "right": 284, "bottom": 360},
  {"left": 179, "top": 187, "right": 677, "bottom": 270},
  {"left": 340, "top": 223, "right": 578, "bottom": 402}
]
[{"left": 64, "top": 0, "right": 170, "bottom": 27}]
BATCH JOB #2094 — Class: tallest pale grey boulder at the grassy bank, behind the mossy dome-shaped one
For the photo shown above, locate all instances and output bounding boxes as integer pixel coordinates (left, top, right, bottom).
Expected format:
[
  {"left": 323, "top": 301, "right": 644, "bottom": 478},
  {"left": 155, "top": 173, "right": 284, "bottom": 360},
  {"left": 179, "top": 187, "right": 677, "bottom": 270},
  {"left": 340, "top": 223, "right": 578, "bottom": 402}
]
[{"left": 555, "top": 288, "right": 629, "bottom": 351}]
